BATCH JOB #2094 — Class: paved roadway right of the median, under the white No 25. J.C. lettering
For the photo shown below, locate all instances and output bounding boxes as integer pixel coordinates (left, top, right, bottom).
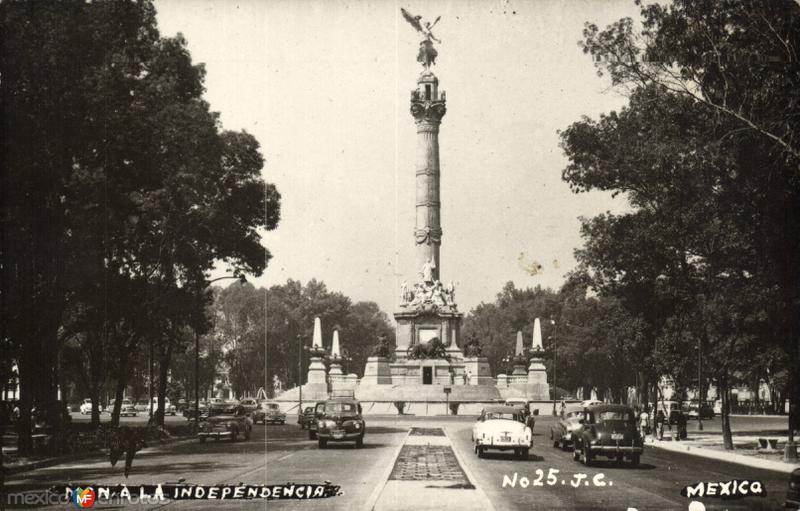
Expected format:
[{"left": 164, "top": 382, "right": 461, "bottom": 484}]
[{"left": 447, "top": 417, "right": 788, "bottom": 510}]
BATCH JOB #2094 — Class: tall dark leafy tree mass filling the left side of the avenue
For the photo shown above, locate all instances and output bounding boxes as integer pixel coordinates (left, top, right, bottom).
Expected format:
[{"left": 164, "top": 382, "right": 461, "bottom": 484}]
[{"left": 0, "top": 1, "right": 280, "bottom": 452}]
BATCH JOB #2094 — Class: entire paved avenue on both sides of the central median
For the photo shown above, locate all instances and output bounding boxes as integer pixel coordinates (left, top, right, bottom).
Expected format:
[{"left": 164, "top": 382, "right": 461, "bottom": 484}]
[{"left": 6, "top": 417, "right": 787, "bottom": 510}]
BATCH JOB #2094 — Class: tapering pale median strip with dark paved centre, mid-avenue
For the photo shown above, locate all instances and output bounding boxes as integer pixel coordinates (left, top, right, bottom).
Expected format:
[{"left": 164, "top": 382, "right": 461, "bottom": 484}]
[{"left": 363, "top": 427, "right": 495, "bottom": 511}]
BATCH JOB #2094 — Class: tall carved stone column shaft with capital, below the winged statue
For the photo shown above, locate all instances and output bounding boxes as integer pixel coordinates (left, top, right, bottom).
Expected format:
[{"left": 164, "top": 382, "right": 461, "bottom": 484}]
[{"left": 411, "top": 69, "right": 447, "bottom": 280}]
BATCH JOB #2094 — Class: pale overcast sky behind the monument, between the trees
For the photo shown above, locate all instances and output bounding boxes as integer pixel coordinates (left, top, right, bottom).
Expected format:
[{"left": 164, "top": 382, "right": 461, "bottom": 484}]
[{"left": 156, "top": 0, "right": 638, "bottom": 320}]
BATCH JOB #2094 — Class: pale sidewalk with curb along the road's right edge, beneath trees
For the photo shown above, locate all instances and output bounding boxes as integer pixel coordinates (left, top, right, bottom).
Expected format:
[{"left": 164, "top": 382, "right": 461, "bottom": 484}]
[{"left": 646, "top": 433, "right": 800, "bottom": 474}]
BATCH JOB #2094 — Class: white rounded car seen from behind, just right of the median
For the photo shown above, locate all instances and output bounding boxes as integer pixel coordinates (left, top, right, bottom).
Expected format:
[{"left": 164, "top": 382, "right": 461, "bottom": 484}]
[{"left": 472, "top": 405, "right": 533, "bottom": 459}]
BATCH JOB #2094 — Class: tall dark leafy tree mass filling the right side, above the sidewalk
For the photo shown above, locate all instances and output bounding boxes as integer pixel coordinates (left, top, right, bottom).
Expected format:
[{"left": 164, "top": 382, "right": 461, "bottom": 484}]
[{"left": 562, "top": 2, "right": 800, "bottom": 446}]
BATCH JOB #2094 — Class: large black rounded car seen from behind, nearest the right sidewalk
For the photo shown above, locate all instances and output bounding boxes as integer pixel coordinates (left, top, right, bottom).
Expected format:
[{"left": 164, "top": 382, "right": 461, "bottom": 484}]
[{"left": 572, "top": 404, "right": 644, "bottom": 467}]
